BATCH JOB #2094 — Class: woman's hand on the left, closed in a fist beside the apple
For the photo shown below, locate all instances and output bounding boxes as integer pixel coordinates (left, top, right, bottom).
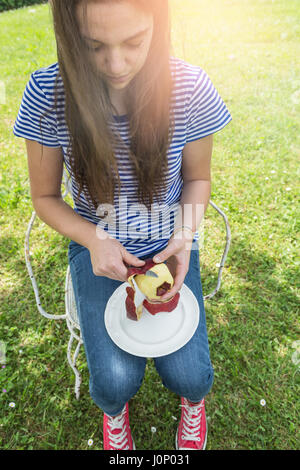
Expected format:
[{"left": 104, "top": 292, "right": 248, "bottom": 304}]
[{"left": 87, "top": 230, "right": 145, "bottom": 282}]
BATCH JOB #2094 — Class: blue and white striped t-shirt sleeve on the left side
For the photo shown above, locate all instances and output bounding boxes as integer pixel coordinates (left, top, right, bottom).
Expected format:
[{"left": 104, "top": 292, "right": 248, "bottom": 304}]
[{"left": 13, "top": 73, "right": 61, "bottom": 148}]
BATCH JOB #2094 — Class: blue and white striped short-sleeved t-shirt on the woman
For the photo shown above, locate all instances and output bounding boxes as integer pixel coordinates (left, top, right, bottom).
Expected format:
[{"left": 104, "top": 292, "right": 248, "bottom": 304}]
[{"left": 13, "top": 56, "right": 232, "bottom": 256}]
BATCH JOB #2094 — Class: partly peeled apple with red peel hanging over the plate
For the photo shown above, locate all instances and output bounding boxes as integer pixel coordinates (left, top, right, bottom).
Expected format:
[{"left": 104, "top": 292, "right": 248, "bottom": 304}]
[{"left": 126, "top": 259, "right": 180, "bottom": 321}]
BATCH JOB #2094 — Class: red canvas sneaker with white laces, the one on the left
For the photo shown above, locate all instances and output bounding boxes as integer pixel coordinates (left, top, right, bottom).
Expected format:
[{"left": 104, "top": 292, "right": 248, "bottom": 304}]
[{"left": 103, "top": 403, "right": 135, "bottom": 450}]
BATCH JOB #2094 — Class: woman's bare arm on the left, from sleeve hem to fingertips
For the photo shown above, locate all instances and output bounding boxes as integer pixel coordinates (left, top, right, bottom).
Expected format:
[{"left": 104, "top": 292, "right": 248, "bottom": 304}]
[{"left": 26, "top": 140, "right": 145, "bottom": 281}]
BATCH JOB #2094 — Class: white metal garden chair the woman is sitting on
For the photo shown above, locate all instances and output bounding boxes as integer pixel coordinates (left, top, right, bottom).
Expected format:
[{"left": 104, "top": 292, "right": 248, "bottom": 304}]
[{"left": 25, "top": 170, "right": 231, "bottom": 400}]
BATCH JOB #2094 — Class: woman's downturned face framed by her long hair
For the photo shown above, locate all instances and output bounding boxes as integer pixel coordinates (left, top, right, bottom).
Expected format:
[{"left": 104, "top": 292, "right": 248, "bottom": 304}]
[{"left": 76, "top": 0, "right": 153, "bottom": 91}]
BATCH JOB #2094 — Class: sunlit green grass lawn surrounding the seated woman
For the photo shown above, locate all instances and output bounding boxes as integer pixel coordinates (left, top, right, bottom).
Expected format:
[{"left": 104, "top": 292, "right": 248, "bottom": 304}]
[{"left": 0, "top": 0, "right": 300, "bottom": 450}]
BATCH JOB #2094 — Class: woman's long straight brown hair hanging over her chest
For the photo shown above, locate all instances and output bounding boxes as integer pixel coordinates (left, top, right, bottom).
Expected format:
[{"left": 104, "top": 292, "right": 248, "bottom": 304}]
[{"left": 49, "top": 0, "right": 174, "bottom": 209}]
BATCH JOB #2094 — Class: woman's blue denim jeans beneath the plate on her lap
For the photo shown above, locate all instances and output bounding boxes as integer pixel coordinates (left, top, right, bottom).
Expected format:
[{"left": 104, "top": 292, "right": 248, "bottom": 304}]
[{"left": 68, "top": 241, "right": 214, "bottom": 416}]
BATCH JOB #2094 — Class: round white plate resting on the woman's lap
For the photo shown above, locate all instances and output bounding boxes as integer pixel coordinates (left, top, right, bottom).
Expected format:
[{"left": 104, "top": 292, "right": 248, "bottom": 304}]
[{"left": 104, "top": 282, "right": 200, "bottom": 357}]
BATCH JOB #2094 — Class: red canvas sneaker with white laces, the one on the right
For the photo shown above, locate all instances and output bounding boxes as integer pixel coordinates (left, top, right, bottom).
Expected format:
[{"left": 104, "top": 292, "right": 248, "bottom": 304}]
[{"left": 175, "top": 397, "right": 207, "bottom": 450}]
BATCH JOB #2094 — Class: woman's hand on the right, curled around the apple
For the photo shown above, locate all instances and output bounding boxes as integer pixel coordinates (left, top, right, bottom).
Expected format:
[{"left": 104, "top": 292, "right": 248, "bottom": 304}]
[{"left": 153, "top": 233, "right": 192, "bottom": 301}]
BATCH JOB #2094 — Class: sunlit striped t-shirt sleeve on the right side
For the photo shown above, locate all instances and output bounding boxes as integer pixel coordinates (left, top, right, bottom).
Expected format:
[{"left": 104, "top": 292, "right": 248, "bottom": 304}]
[{"left": 186, "top": 69, "right": 232, "bottom": 142}]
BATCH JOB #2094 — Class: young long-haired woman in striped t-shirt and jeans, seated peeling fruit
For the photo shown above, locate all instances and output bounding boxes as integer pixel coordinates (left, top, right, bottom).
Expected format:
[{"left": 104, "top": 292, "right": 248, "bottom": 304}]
[{"left": 14, "top": 0, "right": 231, "bottom": 450}]
